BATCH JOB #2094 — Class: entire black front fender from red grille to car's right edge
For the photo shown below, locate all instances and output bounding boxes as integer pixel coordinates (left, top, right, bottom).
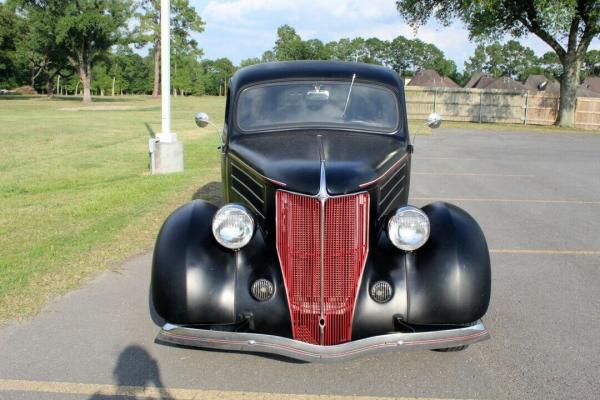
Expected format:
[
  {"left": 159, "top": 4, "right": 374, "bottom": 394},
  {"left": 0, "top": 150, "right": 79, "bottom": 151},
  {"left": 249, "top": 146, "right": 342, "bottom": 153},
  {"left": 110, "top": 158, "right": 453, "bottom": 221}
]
[{"left": 352, "top": 202, "right": 491, "bottom": 340}]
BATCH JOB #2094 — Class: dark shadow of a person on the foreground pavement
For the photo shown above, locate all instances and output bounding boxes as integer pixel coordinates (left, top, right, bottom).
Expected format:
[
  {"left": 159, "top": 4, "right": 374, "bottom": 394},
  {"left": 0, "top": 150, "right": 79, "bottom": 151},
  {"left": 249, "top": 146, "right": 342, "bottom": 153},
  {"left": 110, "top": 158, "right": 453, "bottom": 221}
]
[{"left": 89, "top": 345, "right": 173, "bottom": 400}]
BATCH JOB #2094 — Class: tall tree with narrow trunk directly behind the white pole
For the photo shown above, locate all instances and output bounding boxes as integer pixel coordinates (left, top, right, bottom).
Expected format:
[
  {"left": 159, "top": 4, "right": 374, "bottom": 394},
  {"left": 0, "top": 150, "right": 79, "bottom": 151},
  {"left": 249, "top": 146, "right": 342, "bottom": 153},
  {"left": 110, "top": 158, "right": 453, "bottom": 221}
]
[{"left": 133, "top": 0, "right": 204, "bottom": 97}]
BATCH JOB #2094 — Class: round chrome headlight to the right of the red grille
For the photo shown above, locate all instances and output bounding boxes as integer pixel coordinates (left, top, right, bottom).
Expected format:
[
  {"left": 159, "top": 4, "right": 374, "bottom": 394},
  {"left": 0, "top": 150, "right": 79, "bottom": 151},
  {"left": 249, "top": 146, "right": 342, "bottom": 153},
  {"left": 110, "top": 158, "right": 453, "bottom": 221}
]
[{"left": 388, "top": 206, "right": 429, "bottom": 251}]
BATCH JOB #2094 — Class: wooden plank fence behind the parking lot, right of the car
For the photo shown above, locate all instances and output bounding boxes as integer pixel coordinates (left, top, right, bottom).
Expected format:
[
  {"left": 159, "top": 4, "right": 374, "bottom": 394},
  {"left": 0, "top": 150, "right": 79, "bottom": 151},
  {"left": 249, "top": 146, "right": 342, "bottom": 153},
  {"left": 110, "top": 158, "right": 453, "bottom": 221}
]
[{"left": 405, "top": 86, "right": 600, "bottom": 129}]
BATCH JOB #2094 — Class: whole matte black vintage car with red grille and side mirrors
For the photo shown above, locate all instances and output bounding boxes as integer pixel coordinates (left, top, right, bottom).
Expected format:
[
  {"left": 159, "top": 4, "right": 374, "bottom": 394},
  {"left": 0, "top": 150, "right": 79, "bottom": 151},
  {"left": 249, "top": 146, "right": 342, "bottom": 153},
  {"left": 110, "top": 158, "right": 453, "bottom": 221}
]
[{"left": 151, "top": 61, "right": 491, "bottom": 361}]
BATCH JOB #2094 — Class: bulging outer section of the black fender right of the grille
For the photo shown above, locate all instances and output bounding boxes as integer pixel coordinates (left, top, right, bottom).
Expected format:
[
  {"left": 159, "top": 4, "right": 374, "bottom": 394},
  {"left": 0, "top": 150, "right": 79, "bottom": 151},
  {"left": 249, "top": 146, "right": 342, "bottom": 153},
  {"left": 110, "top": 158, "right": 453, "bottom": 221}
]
[{"left": 406, "top": 202, "right": 492, "bottom": 325}]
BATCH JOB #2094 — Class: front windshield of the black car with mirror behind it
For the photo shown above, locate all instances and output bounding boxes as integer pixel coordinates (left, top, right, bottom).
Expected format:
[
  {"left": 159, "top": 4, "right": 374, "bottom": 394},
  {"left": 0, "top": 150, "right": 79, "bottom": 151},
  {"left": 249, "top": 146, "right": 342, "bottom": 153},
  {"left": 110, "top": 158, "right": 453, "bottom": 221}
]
[{"left": 237, "top": 79, "right": 399, "bottom": 133}]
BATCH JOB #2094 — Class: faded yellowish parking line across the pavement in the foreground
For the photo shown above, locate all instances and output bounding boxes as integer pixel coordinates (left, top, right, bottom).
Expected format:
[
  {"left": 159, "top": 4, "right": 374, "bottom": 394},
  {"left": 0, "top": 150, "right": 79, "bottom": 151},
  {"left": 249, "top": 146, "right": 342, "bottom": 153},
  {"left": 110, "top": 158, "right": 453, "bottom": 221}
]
[{"left": 0, "top": 379, "right": 464, "bottom": 400}]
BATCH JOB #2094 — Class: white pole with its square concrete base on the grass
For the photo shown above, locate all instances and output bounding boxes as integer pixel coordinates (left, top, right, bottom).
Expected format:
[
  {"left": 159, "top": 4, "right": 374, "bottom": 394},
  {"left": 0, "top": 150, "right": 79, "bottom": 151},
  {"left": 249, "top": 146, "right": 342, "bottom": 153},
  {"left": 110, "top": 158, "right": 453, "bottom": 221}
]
[{"left": 149, "top": 0, "right": 183, "bottom": 174}]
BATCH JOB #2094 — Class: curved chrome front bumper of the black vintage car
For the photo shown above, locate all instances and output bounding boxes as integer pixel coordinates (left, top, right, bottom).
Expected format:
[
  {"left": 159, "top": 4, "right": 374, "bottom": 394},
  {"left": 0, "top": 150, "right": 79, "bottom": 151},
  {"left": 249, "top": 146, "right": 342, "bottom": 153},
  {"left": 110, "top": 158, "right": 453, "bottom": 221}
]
[{"left": 156, "top": 321, "right": 490, "bottom": 362}]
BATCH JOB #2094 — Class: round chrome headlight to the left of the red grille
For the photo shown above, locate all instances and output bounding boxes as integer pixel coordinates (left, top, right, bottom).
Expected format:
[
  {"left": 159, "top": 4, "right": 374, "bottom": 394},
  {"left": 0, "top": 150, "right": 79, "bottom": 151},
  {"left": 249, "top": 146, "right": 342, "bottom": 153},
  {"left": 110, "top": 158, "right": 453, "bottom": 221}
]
[{"left": 212, "top": 204, "right": 254, "bottom": 250}]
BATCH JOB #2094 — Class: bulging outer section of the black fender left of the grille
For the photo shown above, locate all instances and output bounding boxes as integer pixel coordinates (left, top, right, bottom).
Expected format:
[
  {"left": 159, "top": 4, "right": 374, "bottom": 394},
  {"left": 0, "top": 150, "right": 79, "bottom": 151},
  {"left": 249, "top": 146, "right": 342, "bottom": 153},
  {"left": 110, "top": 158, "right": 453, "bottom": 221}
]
[{"left": 152, "top": 200, "right": 236, "bottom": 324}]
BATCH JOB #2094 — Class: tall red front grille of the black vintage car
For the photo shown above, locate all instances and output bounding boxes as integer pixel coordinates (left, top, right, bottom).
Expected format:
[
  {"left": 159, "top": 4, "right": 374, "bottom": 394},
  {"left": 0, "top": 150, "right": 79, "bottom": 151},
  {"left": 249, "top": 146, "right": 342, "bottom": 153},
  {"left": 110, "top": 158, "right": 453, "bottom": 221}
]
[{"left": 276, "top": 191, "right": 369, "bottom": 345}]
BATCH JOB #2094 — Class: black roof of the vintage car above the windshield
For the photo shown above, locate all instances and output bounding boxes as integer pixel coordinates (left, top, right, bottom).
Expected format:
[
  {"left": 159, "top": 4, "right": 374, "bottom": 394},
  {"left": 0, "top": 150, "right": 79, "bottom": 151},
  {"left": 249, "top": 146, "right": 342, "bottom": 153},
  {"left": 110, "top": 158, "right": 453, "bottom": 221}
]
[{"left": 230, "top": 61, "right": 402, "bottom": 94}]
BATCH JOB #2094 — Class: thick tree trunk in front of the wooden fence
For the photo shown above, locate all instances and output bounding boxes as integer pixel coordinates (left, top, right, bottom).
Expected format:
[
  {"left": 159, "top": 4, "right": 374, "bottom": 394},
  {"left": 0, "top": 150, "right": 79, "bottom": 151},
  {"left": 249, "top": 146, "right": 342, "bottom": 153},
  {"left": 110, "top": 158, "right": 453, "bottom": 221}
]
[{"left": 558, "top": 53, "right": 581, "bottom": 128}]
